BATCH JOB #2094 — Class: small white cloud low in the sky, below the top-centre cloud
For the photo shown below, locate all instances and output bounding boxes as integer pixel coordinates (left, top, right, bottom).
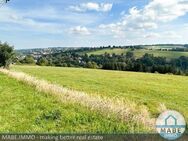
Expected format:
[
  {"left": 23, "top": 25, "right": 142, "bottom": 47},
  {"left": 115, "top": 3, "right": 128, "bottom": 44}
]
[{"left": 70, "top": 26, "right": 91, "bottom": 35}]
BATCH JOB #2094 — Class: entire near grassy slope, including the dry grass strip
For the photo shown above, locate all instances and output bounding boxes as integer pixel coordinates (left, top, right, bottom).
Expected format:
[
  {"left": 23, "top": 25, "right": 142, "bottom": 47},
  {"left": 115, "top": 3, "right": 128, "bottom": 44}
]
[{"left": 0, "top": 66, "right": 188, "bottom": 133}]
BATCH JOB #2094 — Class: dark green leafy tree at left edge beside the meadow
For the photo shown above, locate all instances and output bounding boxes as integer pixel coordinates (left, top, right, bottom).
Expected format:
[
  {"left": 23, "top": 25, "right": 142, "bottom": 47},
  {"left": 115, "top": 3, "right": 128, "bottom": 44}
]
[{"left": 0, "top": 43, "right": 14, "bottom": 69}]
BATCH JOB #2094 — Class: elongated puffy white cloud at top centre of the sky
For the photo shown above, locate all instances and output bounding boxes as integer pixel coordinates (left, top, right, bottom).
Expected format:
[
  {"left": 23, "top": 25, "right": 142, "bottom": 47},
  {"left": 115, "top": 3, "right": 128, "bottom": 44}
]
[{"left": 69, "top": 2, "right": 113, "bottom": 12}]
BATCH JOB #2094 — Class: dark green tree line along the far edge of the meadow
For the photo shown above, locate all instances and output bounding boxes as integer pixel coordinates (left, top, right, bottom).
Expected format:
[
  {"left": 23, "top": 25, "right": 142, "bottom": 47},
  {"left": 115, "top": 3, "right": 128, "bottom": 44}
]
[{"left": 20, "top": 51, "right": 188, "bottom": 75}]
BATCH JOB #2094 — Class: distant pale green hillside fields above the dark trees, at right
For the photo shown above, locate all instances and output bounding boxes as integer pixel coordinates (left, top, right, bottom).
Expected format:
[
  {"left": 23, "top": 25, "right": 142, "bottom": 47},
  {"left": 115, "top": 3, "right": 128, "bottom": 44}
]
[{"left": 88, "top": 49, "right": 188, "bottom": 58}]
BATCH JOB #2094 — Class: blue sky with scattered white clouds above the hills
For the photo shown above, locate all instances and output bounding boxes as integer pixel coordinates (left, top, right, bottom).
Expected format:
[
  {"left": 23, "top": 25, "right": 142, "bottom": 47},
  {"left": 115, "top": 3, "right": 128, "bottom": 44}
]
[{"left": 0, "top": 0, "right": 188, "bottom": 49}]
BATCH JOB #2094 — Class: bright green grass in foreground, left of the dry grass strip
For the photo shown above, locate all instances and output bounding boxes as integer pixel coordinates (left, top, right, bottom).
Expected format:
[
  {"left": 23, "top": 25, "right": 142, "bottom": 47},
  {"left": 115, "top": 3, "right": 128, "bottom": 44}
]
[{"left": 0, "top": 72, "right": 144, "bottom": 133}]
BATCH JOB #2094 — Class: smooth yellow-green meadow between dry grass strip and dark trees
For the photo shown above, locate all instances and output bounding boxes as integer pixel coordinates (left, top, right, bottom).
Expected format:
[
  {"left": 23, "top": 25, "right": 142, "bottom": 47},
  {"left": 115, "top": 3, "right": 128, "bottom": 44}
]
[{"left": 12, "top": 66, "right": 188, "bottom": 124}]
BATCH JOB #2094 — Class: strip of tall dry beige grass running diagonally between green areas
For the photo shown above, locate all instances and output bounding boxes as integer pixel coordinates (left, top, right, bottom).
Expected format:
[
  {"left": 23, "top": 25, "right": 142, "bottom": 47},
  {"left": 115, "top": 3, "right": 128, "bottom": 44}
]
[{"left": 0, "top": 69, "right": 157, "bottom": 131}]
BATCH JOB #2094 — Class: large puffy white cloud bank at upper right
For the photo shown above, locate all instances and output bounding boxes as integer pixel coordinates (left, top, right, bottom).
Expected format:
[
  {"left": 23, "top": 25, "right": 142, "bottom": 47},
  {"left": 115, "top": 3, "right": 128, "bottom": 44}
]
[{"left": 99, "top": 0, "right": 188, "bottom": 37}]
